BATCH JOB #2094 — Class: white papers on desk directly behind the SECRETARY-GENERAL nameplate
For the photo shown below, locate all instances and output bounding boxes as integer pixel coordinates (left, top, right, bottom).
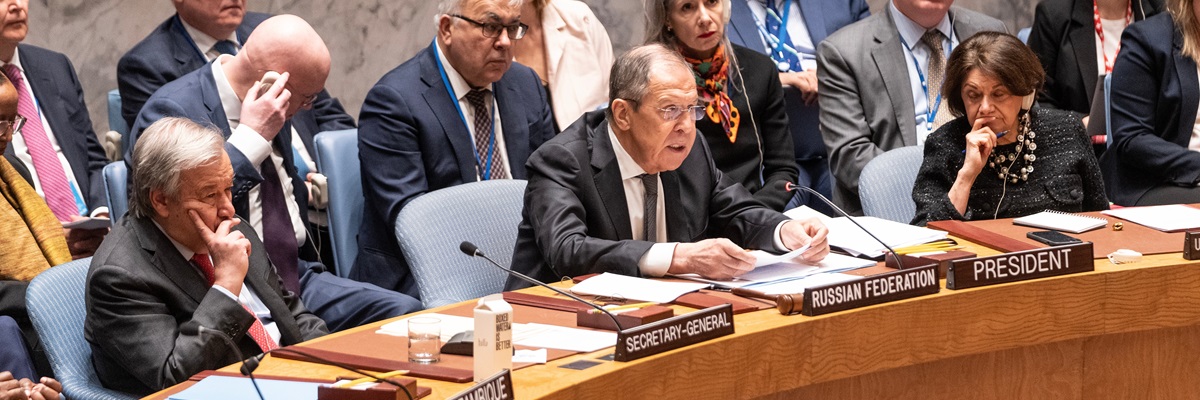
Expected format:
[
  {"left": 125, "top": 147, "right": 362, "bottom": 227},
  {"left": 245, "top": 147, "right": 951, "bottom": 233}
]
[{"left": 571, "top": 273, "right": 708, "bottom": 303}]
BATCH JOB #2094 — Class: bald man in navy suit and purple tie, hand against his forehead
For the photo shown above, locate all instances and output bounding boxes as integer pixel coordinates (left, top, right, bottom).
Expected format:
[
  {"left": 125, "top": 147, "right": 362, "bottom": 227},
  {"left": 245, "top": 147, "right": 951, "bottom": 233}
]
[{"left": 126, "top": 16, "right": 420, "bottom": 330}]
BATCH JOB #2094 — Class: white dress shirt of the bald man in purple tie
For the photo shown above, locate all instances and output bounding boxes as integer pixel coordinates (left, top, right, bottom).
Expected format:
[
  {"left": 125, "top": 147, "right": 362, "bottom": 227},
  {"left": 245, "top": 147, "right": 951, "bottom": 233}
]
[{"left": 211, "top": 55, "right": 308, "bottom": 245}]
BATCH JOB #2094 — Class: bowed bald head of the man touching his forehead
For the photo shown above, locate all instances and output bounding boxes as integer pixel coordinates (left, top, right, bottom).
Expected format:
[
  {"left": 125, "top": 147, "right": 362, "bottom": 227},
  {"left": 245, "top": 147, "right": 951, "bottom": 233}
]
[{"left": 223, "top": 14, "right": 330, "bottom": 118}]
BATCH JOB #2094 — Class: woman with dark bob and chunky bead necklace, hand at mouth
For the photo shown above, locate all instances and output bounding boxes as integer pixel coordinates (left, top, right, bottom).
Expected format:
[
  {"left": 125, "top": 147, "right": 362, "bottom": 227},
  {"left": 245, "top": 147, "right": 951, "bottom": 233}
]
[{"left": 912, "top": 32, "right": 1109, "bottom": 225}]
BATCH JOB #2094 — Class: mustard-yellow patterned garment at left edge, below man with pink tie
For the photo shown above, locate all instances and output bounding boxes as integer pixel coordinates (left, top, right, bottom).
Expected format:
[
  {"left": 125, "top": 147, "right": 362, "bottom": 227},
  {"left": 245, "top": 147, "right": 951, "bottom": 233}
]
[{"left": 0, "top": 157, "right": 71, "bottom": 282}]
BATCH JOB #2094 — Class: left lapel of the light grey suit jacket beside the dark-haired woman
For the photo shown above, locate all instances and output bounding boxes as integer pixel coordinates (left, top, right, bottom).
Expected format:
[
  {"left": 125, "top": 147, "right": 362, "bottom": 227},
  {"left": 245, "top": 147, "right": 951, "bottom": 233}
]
[{"left": 871, "top": 10, "right": 917, "bottom": 145}]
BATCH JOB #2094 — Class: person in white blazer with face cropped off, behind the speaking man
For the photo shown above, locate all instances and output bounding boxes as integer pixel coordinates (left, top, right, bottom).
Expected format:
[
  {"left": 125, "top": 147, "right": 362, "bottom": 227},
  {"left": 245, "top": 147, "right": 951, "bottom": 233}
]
[{"left": 512, "top": 0, "right": 613, "bottom": 131}]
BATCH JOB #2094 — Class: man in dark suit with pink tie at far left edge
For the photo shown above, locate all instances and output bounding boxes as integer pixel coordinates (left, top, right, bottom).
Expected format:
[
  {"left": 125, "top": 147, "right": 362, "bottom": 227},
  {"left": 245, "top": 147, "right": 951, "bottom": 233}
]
[{"left": 0, "top": 0, "right": 108, "bottom": 246}]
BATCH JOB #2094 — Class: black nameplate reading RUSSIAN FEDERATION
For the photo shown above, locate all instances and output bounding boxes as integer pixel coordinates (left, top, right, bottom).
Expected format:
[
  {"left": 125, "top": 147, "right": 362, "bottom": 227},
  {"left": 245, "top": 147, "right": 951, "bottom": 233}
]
[{"left": 800, "top": 264, "right": 941, "bottom": 317}]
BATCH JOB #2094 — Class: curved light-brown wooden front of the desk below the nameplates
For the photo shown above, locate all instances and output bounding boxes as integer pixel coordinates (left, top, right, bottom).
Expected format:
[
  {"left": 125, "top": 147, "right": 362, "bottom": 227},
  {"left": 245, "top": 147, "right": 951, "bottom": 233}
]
[{"left": 150, "top": 237, "right": 1200, "bottom": 400}]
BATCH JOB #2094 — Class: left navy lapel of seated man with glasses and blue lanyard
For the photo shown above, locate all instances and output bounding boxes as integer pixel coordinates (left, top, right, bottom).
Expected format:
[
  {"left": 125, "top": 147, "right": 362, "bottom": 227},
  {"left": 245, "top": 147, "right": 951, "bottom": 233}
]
[{"left": 419, "top": 43, "right": 479, "bottom": 181}]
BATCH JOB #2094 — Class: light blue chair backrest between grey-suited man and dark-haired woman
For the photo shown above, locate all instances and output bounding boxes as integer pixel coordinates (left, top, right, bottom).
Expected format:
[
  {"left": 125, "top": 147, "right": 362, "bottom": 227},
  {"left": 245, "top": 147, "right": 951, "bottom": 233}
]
[{"left": 858, "top": 145, "right": 925, "bottom": 223}]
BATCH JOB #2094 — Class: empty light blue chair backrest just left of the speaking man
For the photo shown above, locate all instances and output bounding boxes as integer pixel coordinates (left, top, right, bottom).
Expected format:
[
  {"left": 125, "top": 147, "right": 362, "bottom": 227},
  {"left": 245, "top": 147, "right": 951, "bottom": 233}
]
[{"left": 396, "top": 179, "right": 526, "bottom": 308}]
